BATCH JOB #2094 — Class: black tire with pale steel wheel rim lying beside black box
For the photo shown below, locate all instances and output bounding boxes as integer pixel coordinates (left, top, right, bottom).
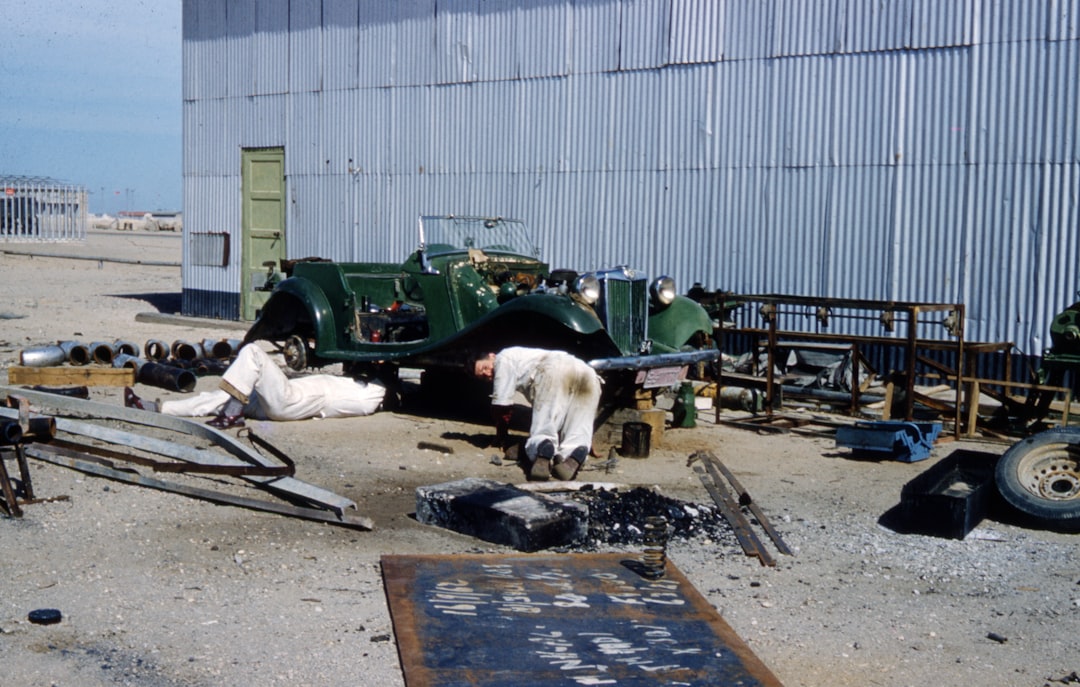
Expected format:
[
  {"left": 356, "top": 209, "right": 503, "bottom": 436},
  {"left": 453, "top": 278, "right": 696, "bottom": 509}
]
[{"left": 995, "top": 428, "right": 1080, "bottom": 531}]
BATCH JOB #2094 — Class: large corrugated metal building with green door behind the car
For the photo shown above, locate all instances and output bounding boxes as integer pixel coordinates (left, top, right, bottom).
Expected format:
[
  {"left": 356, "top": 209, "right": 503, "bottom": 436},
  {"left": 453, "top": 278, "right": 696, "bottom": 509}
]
[{"left": 184, "top": 0, "right": 1080, "bottom": 369}]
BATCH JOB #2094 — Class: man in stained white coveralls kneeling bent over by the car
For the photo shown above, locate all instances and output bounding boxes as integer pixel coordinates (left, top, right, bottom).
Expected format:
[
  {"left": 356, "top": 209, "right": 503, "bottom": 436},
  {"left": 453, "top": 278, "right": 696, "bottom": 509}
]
[{"left": 472, "top": 347, "right": 600, "bottom": 480}]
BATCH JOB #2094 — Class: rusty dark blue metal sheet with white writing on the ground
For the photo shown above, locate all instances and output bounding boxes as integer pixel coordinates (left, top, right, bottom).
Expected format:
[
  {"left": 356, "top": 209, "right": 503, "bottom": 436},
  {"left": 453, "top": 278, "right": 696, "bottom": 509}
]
[{"left": 382, "top": 553, "right": 780, "bottom": 687}]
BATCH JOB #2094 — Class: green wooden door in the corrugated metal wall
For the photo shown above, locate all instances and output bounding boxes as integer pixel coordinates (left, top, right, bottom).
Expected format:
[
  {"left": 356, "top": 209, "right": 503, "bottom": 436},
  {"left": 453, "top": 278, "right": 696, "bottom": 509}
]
[{"left": 240, "top": 148, "right": 285, "bottom": 321}]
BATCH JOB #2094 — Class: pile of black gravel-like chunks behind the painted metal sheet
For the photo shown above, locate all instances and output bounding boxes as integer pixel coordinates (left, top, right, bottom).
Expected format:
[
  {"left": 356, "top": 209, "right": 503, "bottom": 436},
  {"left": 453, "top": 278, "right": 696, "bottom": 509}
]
[{"left": 571, "top": 487, "right": 733, "bottom": 547}]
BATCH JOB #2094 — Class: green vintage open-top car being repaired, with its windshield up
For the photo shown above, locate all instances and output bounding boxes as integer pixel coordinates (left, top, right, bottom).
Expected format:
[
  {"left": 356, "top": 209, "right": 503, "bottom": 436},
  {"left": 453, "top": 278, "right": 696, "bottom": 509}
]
[{"left": 245, "top": 216, "right": 719, "bottom": 399}]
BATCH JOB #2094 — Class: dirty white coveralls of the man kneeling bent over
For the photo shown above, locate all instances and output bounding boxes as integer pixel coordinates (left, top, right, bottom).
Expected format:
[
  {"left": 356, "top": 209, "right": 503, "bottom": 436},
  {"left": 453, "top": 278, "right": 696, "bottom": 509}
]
[{"left": 491, "top": 347, "right": 600, "bottom": 459}]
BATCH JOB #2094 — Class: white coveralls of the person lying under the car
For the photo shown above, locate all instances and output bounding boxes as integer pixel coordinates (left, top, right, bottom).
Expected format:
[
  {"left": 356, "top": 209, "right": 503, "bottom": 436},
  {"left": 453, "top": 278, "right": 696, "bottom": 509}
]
[{"left": 161, "top": 344, "right": 387, "bottom": 420}]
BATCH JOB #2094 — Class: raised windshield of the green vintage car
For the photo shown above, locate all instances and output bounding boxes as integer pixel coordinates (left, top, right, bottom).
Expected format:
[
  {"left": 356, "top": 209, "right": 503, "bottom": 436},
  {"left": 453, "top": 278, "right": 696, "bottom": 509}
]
[{"left": 420, "top": 216, "right": 540, "bottom": 258}]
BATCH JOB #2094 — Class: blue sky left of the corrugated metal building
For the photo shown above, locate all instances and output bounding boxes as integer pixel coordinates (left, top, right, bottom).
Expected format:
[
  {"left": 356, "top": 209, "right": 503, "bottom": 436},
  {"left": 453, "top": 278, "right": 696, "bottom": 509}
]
[{"left": 0, "top": 0, "right": 183, "bottom": 215}]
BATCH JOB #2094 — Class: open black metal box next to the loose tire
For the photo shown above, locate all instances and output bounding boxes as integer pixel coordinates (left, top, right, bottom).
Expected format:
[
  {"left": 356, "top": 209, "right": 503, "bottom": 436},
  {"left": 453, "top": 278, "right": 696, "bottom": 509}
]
[{"left": 900, "top": 448, "right": 999, "bottom": 539}]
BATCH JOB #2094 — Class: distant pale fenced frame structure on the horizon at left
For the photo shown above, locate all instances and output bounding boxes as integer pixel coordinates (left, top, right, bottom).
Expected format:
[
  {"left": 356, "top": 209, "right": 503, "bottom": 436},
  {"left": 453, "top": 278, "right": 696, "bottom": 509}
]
[{"left": 0, "top": 181, "right": 86, "bottom": 241}]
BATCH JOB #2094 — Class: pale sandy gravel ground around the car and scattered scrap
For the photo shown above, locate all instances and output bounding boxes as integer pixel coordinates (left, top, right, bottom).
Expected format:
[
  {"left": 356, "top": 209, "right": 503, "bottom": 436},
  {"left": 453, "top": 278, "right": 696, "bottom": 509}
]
[{"left": 0, "top": 232, "right": 1080, "bottom": 687}]
